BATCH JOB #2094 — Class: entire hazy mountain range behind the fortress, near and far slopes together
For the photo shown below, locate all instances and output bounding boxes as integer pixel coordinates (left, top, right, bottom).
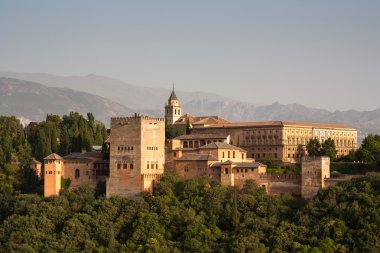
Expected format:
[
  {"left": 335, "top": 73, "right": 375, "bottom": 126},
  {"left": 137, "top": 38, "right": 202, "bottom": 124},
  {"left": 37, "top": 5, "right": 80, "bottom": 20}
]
[{"left": 0, "top": 72, "right": 380, "bottom": 142}]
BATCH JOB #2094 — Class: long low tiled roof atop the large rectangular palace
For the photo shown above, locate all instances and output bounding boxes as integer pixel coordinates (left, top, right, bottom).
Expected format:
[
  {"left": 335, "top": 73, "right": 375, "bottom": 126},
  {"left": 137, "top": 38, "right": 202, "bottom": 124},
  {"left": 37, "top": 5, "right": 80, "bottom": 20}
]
[{"left": 196, "top": 121, "right": 355, "bottom": 130}]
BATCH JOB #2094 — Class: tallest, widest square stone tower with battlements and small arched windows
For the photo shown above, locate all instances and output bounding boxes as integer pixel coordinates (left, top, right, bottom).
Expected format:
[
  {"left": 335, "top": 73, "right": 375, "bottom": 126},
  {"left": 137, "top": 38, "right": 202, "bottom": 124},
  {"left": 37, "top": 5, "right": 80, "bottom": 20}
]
[{"left": 106, "top": 116, "right": 165, "bottom": 197}]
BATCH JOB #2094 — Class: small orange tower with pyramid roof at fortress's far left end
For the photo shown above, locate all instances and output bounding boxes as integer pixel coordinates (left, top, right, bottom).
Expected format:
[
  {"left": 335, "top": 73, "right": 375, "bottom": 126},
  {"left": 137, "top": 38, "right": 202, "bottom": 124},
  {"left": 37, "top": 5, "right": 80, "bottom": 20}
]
[{"left": 44, "top": 153, "right": 63, "bottom": 197}]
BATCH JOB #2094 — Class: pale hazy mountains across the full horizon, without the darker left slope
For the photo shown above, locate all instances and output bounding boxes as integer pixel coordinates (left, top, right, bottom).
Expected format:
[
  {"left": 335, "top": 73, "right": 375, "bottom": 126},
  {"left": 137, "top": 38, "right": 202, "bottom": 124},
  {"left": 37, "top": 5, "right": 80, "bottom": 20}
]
[{"left": 0, "top": 72, "right": 380, "bottom": 142}]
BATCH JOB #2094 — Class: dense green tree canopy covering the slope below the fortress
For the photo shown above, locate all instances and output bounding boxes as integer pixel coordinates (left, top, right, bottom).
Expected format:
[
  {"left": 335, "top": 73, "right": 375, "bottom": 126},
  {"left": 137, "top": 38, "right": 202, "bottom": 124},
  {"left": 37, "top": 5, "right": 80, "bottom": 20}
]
[{"left": 0, "top": 174, "right": 380, "bottom": 252}]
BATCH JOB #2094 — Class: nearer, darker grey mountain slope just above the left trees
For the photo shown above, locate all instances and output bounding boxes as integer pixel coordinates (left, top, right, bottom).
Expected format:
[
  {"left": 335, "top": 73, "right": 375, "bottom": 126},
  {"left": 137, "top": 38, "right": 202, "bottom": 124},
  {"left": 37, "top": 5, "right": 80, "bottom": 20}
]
[{"left": 0, "top": 77, "right": 132, "bottom": 123}]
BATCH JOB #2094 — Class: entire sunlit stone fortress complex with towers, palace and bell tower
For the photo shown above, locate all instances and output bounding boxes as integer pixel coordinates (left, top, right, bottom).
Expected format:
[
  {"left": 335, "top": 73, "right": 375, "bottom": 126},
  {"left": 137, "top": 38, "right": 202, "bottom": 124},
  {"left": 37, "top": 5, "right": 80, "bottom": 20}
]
[{"left": 42, "top": 88, "right": 357, "bottom": 198}]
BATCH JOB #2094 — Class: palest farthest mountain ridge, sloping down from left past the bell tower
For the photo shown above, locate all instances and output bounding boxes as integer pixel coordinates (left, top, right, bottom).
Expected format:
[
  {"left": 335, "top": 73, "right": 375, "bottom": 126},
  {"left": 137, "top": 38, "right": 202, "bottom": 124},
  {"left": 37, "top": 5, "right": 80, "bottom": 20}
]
[{"left": 0, "top": 72, "right": 238, "bottom": 116}]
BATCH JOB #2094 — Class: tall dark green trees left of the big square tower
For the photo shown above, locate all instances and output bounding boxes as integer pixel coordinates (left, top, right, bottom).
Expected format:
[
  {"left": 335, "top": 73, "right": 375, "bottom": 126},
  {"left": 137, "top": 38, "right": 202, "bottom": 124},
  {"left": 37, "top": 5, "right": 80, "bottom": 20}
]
[{"left": 0, "top": 113, "right": 107, "bottom": 194}]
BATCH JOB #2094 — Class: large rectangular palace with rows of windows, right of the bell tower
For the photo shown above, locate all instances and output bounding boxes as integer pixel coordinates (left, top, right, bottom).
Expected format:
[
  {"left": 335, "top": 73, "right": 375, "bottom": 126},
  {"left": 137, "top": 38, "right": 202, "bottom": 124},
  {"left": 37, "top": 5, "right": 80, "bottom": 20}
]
[{"left": 191, "top": 121, "right": 357, "bottom": 163}]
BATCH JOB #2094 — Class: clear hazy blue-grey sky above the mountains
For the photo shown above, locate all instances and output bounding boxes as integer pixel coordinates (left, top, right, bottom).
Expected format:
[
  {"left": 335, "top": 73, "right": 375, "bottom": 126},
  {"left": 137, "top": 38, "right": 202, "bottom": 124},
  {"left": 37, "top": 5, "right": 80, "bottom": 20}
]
[{"left": 0, "top": 0, "right": 380, "bottom": 110}]
